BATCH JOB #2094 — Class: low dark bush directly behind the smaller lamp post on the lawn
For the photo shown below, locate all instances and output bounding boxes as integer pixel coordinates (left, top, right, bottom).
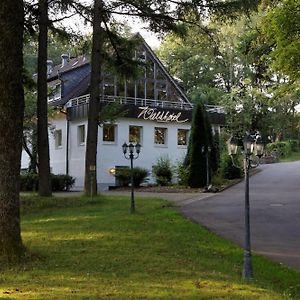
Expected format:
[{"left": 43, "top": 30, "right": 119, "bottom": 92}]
[{"left": 115, "top": 167, "right": 149, "bottom": 187}]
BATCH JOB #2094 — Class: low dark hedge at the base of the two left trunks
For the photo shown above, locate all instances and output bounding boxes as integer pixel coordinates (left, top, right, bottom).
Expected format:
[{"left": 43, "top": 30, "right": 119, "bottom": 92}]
[{"left": 20, "top": 173, "right": 75, "bottom": 191}]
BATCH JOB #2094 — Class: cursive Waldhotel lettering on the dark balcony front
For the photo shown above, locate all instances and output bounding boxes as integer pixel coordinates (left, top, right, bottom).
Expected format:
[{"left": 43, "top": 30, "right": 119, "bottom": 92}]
[{"left": 137, "top": 106, "right": 189, "bottom": 123}]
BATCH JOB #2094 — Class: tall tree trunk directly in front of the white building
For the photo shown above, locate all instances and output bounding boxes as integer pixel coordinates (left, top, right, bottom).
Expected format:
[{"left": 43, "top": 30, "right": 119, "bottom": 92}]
[{"left": 84, "top": 0, "right": 103, "bottom": 195}]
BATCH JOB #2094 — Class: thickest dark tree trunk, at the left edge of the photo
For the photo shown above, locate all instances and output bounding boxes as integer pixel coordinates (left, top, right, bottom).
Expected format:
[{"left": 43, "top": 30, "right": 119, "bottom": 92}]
[{"left": 0, "top": 0, "right": 24, "bottom": 263}]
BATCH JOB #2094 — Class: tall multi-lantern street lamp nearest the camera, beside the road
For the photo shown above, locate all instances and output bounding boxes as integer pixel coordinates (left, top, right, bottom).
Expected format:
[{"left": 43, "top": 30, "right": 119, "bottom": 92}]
[{"left": 228, "top": 133, "right": 264, "bottom": 279}]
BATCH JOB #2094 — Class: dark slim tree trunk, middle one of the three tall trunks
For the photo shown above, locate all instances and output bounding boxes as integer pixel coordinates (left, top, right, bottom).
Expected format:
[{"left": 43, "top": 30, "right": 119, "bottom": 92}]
[{"left": 37, "top": 0, "right": 52, "bottom": 197}]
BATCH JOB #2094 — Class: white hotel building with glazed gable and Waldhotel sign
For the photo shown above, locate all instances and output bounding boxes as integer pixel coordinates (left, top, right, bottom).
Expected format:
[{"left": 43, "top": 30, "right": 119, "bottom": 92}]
[{"left": 22, "top": 34, "right": 224, "bottom": 189}]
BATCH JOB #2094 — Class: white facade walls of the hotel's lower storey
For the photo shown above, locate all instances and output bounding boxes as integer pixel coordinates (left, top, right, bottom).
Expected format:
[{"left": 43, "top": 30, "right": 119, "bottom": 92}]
[{"left": 22, "top": 114, "right": 219, "bottom": 189}]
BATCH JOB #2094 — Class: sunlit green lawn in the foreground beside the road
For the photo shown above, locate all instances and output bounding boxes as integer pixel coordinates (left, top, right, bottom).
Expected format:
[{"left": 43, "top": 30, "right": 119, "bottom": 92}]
[{"left": 0, "top": 196, "right": 300, "bottom": 300}]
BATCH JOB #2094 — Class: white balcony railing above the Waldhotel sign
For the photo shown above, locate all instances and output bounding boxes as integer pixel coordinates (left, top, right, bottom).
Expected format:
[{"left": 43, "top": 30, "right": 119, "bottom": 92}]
[{"left": 66, "top": 94, "right": 224, "bottom": 113}]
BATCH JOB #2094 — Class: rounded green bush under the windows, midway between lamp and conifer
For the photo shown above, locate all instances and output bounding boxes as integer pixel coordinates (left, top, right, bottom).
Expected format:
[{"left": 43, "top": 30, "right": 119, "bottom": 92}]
[{"left": 153, "top": 157, "right": 173, "bottom": 186}]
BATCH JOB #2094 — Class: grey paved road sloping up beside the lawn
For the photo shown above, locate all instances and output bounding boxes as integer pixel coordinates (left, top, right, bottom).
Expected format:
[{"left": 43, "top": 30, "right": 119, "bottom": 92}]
[{"left": 181, "top": 162, "right": 300, "bottom": 270}]
